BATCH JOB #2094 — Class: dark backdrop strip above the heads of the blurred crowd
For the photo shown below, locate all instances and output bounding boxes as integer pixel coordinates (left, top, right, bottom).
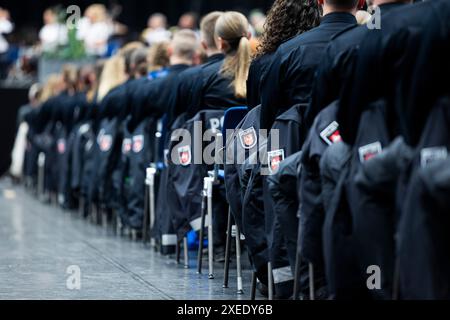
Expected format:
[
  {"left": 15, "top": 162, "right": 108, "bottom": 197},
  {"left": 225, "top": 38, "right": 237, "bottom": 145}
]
[{"left": 0, "top": 0, "right": 273, "bottom": 42}]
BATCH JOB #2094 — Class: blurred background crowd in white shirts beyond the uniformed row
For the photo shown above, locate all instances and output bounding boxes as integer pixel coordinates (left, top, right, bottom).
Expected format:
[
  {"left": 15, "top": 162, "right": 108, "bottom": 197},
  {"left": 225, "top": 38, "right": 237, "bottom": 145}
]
[{"left": 0, "top": 4, "right": 265, "bottom": 81}]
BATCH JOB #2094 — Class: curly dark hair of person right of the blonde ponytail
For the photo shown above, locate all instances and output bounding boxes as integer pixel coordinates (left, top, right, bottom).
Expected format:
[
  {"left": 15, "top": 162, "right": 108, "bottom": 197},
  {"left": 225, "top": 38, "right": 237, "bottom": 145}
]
[{"left": 256, "top": 0, "right": 321, "bottom": 57}]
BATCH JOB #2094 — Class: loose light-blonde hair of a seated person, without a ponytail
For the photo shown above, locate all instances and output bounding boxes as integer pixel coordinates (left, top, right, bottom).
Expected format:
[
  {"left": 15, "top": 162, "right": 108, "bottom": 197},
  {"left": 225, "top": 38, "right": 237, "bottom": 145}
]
[{"left": 97, "top": 55, "right": 127, "bottom": 102}]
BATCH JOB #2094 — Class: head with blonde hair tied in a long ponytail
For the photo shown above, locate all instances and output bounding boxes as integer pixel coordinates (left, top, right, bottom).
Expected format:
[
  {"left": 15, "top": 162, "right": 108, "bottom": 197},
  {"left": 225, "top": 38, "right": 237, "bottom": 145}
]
[{"left": 216, "top": 11, "right": 251, "bottom": 98}]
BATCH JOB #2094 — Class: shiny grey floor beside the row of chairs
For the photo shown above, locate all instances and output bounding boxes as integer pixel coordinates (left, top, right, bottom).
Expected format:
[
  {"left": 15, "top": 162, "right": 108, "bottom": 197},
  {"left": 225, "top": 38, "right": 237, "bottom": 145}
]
[{"left": 0, "top": 180, "right": 260, "bottom": 300}]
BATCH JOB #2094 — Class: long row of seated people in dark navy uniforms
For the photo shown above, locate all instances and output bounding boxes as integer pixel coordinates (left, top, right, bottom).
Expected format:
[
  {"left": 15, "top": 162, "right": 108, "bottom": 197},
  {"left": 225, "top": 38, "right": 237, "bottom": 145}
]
[{"left": 20, "top": 0, "right": 450, "bottom": 299}]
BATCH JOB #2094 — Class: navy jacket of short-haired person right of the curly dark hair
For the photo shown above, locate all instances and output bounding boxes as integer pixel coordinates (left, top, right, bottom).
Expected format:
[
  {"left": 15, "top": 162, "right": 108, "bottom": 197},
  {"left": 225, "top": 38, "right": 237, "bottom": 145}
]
[{"left": 261, "top": 12, "right": 356, "bottom": 129}]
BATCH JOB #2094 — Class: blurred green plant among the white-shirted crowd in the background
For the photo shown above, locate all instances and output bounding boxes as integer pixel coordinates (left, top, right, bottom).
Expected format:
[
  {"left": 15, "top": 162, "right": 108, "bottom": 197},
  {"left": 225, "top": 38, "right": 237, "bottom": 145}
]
[{"left": 43, "top": 6, "right": 87, "bottom": 61}]
